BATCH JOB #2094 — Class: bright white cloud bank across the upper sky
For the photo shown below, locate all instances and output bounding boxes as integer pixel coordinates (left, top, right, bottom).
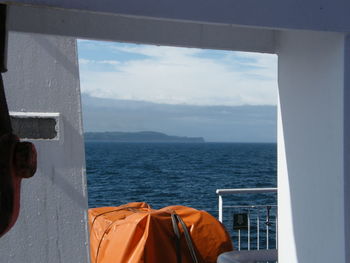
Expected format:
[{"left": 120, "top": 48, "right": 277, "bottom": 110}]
[{"left": 79, "top": 45, "right": 277, "bottom": 105}]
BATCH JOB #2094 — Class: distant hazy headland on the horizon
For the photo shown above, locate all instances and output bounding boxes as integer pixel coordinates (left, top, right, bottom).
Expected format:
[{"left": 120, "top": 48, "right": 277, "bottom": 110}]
[{"left": 84, "top": 131, "right": 205, "bottom": 143}]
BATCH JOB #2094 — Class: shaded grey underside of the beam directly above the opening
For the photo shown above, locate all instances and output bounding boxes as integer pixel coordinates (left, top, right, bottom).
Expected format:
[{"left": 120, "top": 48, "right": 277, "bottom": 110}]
[{"left": 7, "top": 5, "right": 275, "bottom": 53}]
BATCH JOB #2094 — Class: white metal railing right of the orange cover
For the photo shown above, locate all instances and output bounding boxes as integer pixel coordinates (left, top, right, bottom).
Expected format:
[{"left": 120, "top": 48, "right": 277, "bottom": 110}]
[{"left": 216, "top": 188, "right": 278, "bottom": 254}]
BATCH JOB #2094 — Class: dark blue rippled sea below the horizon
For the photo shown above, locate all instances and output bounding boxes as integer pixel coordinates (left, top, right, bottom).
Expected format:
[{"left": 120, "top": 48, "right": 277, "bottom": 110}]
[{"left": 85, "top": 141, "right": 277, "bottom": 250}]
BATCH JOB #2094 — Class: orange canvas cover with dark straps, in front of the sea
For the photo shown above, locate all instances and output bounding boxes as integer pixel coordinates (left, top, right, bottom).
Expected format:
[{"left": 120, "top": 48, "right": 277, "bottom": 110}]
[{"left": 89, "top": 203, "right": 233, "bottom": 263}]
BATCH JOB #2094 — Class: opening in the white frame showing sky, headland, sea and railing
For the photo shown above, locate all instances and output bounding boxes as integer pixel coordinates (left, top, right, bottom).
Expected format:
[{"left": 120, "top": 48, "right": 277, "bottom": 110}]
[{"left": 78, "top": 40, "right": 278, "bottom": 254}]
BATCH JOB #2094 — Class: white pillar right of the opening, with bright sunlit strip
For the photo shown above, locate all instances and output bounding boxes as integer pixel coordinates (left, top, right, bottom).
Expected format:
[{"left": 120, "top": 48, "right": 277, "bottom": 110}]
[{"left": 278, "top": 31, "right": 349, "bottom": 263}]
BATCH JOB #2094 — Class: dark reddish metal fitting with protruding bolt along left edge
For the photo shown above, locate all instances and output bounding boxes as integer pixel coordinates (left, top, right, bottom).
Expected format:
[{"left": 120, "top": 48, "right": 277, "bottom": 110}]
[{"left": 0, "top": 4, "right": 36, "bottom": 237}]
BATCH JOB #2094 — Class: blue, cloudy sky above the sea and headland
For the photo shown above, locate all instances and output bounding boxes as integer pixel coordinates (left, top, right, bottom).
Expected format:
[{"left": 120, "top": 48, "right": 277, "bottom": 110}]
[{"left": 78, "top": 40, "right": 277, "bottom": 142}]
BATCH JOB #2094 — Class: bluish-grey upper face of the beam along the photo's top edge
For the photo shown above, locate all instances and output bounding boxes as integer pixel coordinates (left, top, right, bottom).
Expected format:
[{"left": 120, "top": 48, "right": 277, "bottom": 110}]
[{"left": 0, "top": 0, "right": 350, "bottom": 32}]
